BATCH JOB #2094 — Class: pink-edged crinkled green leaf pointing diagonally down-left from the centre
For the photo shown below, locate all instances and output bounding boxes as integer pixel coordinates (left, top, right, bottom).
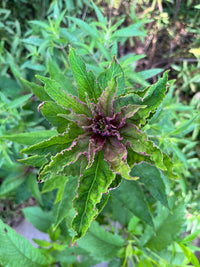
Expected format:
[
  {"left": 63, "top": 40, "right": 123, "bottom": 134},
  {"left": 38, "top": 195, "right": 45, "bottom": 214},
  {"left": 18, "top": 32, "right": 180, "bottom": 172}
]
[{"left": 39, "top": 133, "right": 89, "bottom": 181}]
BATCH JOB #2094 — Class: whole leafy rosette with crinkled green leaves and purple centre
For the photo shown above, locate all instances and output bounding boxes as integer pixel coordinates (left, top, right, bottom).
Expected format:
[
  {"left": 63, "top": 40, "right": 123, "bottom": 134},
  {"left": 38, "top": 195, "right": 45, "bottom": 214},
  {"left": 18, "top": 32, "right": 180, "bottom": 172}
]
[{"left": 22, "top": 49, "right": 177, "bottom": 240}]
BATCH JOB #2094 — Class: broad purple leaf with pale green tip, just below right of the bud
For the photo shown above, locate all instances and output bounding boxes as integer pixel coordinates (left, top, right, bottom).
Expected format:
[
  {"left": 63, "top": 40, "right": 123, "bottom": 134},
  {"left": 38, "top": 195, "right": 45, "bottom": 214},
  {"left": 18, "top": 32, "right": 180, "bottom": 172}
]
[{"left": 103, "top": 137, "right": 133, "bottom": 180}]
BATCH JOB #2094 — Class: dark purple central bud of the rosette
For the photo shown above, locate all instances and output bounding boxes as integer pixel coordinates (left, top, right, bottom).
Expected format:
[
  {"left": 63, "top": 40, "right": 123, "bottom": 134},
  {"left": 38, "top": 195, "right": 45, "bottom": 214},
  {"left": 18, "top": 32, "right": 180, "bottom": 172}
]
[{"left": 92, "top": 115, "right": 116, "bottom": 136}]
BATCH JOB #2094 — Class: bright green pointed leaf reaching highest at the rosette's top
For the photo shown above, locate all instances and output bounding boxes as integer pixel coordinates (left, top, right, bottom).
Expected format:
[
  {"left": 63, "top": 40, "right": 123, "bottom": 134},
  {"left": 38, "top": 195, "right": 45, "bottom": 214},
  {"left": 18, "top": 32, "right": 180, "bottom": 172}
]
[{"left": 69, "top": 48, "right": 102, "bottom": 102}]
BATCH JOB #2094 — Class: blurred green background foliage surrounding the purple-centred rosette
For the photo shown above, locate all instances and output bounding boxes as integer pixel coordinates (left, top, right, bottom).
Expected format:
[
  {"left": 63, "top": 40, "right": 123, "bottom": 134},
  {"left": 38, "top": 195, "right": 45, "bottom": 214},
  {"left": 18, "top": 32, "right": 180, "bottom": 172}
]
[{"left": 0, "top": 0, "right": 200, "bottom": 267}]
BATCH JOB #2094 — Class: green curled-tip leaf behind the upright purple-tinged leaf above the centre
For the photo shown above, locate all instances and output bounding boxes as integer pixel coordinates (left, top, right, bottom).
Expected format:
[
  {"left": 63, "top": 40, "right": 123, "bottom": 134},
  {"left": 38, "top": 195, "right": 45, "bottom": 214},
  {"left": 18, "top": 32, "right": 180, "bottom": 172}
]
[{"left": 97, "top": 57, "right": 125, "bottom": 95}]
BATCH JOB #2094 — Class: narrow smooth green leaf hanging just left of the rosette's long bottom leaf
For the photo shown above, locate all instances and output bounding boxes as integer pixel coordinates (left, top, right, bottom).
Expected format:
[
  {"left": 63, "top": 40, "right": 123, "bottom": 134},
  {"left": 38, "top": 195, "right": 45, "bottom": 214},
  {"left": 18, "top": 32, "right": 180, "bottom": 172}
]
[{"left": 54, "top": 176, "right": 78, "bottom": 229}]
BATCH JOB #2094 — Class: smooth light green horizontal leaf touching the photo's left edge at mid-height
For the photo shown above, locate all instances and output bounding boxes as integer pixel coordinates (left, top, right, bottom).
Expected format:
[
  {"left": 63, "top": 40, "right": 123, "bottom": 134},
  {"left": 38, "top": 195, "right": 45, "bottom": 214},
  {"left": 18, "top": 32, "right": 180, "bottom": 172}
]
[{"left": 0, "top": 130, "right": 57, "bottom": 145}]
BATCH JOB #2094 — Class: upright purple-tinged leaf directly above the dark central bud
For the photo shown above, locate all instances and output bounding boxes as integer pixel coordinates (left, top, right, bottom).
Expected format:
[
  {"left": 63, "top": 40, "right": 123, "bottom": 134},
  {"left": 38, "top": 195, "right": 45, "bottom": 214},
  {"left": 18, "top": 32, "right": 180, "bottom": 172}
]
[{"left": 97, "top": 77, "right": 117, "bottom": 118}]
